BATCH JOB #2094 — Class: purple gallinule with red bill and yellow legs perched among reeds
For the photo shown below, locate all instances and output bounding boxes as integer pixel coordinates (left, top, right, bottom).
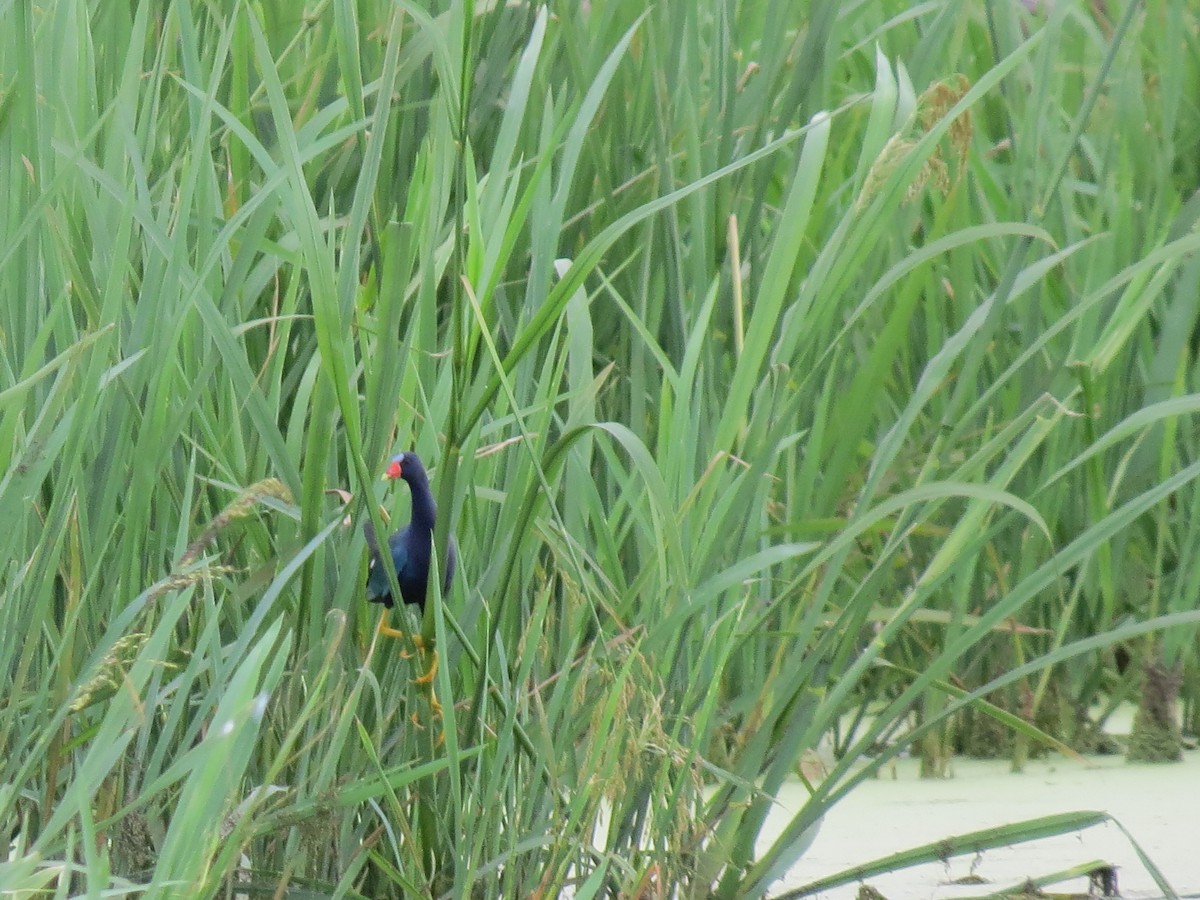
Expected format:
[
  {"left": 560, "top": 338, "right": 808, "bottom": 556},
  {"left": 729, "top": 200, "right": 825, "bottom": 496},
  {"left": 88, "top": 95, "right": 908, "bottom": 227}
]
[{"left": 362, "top": 451, "right": 458, "bottom": 684}]
